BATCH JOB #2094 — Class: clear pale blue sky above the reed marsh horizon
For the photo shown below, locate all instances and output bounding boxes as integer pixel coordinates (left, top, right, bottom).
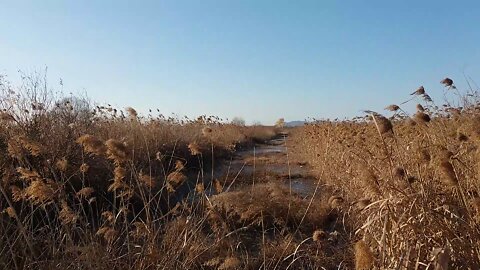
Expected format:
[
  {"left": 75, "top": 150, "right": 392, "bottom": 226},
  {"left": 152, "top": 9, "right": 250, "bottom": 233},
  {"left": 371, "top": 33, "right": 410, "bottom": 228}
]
[{"left": 0, "top": 0, "right": 480, "bottom": 124}]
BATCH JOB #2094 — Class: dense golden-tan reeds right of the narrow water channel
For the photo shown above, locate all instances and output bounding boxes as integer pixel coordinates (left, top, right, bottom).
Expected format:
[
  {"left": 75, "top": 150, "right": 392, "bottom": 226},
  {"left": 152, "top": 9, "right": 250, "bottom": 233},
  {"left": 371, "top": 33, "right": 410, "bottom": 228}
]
[{"left": 292, "top": 78, "right": 480, "bottom": 269}]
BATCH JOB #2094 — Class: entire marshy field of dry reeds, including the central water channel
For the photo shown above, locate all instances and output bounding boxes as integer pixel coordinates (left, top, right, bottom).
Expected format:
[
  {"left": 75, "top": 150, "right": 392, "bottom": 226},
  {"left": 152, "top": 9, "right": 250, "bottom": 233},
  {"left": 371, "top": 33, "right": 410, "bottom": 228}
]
[{"left": 0, "top": 74, "right": 480, "bottom": 269}]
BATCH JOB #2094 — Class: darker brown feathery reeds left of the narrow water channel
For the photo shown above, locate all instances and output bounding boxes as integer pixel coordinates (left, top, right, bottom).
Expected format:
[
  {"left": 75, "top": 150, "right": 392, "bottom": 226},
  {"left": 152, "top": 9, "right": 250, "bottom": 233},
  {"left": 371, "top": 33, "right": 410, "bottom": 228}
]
[{"left": 0, "top": 73, "right": 294, "bottom": 269}]
